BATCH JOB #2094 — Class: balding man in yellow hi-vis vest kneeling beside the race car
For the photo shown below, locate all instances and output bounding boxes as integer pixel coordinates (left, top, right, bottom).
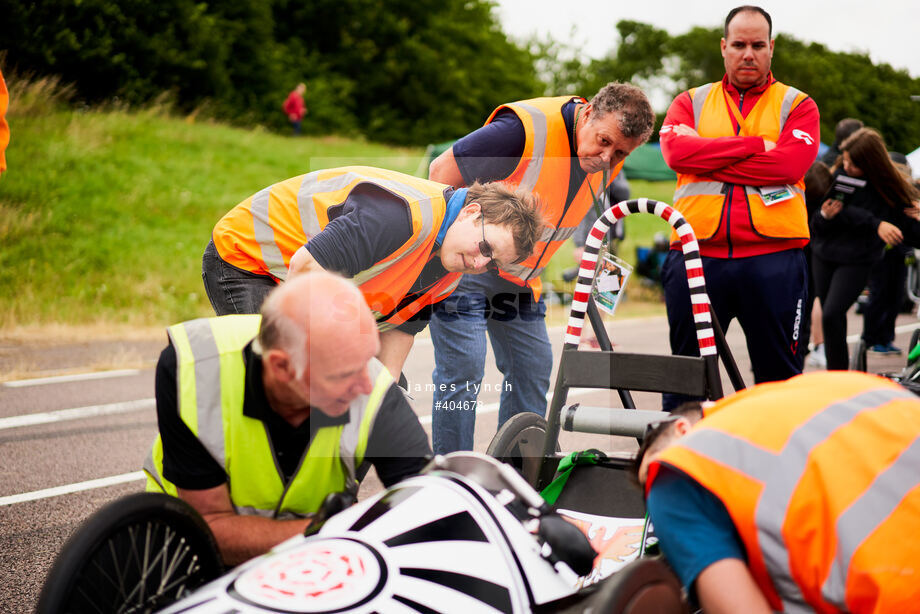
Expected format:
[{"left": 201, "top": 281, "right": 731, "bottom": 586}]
[{"left": 144, "top": 272, "right": 431, "bottom": 565}]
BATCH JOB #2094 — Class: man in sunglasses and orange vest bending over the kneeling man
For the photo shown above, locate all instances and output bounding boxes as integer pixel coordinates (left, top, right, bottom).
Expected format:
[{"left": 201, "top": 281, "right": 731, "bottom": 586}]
[{"left": 202, "top": 166, "right": 541, "bottom": 377}]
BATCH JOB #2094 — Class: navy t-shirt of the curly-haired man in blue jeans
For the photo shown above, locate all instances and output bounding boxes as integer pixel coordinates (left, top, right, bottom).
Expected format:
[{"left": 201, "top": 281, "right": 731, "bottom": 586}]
[{"left": 453, "top": 99, "right": 588, "bottom": 209}]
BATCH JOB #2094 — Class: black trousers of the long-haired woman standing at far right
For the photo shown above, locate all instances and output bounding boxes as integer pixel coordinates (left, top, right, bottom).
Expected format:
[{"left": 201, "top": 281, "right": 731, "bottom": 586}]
[{"left": 812, "top": 254, "right": 872, "bottom": 371}]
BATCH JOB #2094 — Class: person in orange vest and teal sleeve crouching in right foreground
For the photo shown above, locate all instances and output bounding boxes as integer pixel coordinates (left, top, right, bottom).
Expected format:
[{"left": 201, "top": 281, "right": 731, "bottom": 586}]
[{"left": 635, "top": 371, "right": 920, "bottom": 614}]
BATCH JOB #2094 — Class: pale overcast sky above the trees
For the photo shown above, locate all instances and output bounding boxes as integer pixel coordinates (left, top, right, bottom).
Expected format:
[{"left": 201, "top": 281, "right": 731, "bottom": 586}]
[{"left": 496, "top": 0, "right": 920, "bottom": 78}]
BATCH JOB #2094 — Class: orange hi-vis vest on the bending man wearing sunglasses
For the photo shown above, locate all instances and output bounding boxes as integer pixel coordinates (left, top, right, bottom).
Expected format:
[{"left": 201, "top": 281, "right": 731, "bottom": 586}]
[{"left": 212, "top": 166, "right": 460, "bottom": 331}]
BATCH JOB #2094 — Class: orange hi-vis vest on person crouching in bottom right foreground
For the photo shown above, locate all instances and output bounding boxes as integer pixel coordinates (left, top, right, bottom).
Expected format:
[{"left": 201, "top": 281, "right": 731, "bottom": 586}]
[{"left": 646, "top": 372, "right": 920, "bottom": 612}]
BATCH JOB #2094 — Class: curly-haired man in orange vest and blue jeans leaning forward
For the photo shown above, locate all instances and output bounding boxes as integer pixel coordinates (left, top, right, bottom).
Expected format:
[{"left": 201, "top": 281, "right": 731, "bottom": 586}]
[{"left": 429, "top": 83, "right": 655, "bottom": 454}]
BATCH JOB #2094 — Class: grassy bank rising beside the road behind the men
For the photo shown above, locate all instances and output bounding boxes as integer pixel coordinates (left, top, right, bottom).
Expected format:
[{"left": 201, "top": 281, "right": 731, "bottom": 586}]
[{"left": 0, "top": 84, "right": 673, "bottom": 333}]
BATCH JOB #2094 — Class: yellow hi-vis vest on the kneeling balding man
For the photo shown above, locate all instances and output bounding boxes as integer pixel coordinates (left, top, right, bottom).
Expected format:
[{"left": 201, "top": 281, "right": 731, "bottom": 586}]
[{"left": 144, "top": 315, "right": 393, "bottom": 518}]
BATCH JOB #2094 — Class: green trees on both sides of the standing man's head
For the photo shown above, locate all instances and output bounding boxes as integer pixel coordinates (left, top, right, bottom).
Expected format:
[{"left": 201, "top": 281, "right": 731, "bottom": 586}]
[{"left": 541, "top": 20, "right": 920, "bottom": 153}]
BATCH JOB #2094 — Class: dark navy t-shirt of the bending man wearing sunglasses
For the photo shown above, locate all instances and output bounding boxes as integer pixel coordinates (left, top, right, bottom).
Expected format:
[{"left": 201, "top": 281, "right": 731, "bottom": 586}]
[{"left": 307, "top": 183, "right": 454, "bottom": 335}]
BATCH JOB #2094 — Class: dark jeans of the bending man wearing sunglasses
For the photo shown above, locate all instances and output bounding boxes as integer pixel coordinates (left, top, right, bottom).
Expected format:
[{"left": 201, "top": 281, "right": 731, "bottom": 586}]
[{"left": 201, "top": 241, "right": 278, "bottom": 316}]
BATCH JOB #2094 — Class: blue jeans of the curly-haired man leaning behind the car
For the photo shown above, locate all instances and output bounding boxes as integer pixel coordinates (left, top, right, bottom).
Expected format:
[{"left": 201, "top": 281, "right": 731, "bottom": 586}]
[{"left": 431, "top": 273, "right": 553, "bottom": 454}]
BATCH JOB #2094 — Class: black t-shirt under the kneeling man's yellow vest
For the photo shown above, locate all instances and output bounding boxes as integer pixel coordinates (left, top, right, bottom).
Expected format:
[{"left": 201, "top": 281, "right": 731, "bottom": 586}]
[{"left": 156, "top": 344, "right": 431, "bottom": 490}]
